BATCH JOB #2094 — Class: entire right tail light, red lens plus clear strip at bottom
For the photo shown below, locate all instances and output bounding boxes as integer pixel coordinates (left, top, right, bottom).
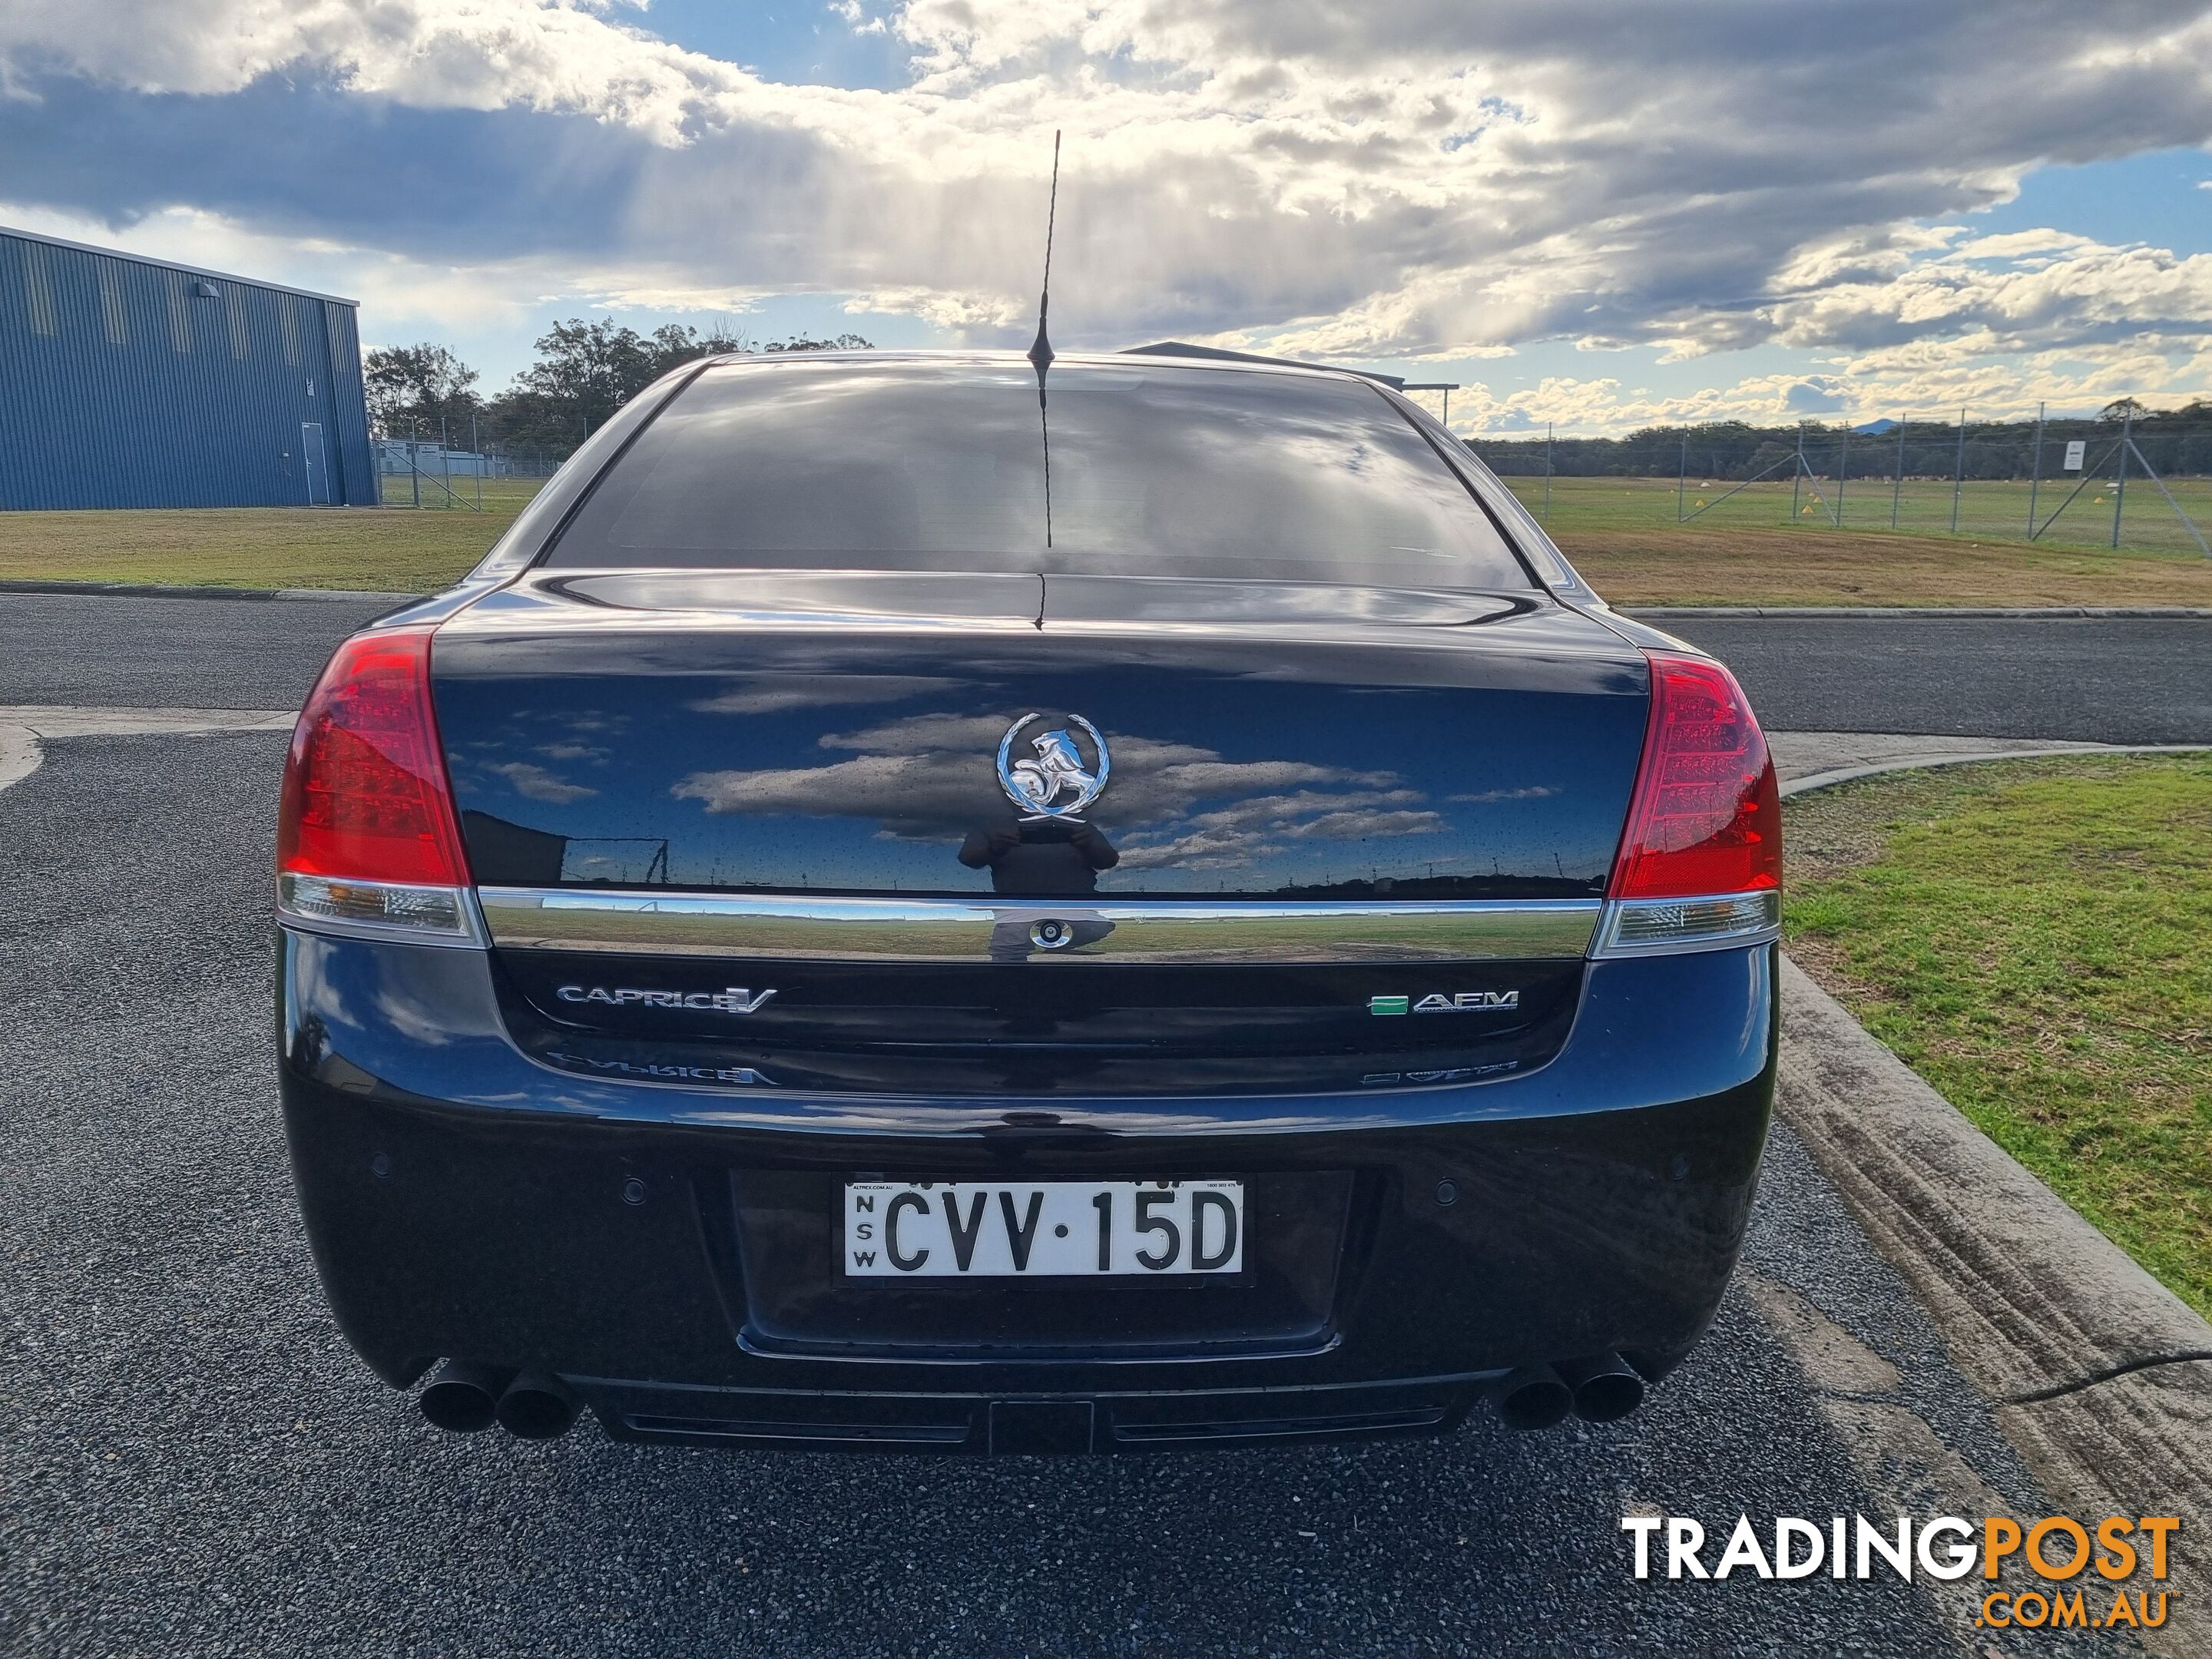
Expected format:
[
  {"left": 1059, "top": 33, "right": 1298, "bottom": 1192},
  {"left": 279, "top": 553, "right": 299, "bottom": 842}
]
[{"left": 1599, "top": 651, "right": 1783, "bottom": 953}]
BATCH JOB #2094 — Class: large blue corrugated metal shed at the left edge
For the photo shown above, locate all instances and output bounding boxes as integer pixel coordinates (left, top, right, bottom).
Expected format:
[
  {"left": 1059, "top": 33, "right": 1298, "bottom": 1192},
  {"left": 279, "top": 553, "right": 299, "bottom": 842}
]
[{"left": 0, "top": 228, "right": 376, "bottom": 508}]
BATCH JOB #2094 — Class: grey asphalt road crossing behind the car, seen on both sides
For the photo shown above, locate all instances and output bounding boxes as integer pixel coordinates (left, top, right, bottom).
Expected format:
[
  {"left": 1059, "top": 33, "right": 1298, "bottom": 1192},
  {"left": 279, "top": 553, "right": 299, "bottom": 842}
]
[{"left": 0, "top": 593, "right": 2212, "bottom": 743}]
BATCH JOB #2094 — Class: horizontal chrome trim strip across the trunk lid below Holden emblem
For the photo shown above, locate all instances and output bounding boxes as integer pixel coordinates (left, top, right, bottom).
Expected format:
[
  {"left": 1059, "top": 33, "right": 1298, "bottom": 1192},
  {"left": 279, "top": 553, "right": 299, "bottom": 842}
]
[{"left": 478, "top": 887, "right": 1601, "bottom": 965}]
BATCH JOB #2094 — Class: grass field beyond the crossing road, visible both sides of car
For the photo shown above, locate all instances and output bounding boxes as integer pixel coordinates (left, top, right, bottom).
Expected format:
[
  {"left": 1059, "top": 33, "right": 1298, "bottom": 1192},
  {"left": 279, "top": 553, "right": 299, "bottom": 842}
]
[{"left": 0, "top": 478, "right": 2212, "bottom": 608}]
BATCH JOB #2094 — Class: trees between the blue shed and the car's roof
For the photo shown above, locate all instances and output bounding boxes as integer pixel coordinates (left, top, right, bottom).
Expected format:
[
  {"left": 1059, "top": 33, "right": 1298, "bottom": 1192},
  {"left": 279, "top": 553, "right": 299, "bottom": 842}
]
[{"left": 363, "top": 316, "right": 869, "bottom": 455}]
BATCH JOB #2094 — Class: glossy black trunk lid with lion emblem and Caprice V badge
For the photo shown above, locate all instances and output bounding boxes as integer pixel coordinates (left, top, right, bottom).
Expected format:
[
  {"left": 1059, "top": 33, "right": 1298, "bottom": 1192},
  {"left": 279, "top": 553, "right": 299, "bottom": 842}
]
[{"left": 433, "top": 571, "right": 1646, "bottom": 1095}]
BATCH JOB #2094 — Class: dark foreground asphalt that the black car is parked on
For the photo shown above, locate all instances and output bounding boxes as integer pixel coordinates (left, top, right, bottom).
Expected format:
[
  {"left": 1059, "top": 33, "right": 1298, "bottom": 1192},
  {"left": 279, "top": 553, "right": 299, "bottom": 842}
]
[{"left": 0, "top": 738, "right": 2079, "bottom": 1657}]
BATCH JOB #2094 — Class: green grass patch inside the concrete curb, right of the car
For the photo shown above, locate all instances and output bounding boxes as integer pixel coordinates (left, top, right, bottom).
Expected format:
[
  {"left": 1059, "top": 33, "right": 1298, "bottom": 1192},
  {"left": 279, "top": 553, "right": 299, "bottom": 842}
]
[{"left": 1785, "top": 757, "right": 2212, "bottom": 1314}]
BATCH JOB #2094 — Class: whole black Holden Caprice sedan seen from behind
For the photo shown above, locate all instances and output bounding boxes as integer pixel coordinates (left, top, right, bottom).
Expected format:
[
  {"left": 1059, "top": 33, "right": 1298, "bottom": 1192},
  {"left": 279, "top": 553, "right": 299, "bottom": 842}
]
[{"left": 276, "top": 352, "right": 1780, "bottom": 1451}]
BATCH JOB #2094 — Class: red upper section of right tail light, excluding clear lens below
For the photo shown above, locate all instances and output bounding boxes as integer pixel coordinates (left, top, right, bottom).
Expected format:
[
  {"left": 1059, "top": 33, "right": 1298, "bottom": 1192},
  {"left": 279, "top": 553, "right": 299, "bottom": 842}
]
[{"left": 1611, "top": 651, "right": 1783, "bottom": 898}]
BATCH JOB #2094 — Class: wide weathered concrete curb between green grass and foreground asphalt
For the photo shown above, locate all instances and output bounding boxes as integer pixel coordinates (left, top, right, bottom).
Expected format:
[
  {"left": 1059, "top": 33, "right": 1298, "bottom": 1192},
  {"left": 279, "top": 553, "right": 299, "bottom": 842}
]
[{"left": 1777, "top": 958, "right": 2212, "bottom": 1650}]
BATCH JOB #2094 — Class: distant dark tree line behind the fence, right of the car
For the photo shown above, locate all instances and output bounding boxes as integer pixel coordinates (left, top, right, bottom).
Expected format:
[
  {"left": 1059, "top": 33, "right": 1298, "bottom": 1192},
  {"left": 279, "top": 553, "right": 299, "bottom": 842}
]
[{"left": 1466, "top": 398, "right": 2212, "bottom": 482}]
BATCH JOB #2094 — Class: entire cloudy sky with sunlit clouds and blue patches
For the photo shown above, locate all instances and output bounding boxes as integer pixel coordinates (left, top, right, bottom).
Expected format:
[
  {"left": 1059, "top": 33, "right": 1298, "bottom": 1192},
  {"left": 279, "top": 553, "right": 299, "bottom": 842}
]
[{"left": 0, "top": 0, "right": 2212, "bottom": 432}]
